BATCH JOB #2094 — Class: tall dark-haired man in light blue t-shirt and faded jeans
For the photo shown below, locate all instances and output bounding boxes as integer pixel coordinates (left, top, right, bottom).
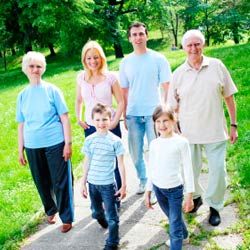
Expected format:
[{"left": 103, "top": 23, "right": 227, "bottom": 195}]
[{"left": 120, "top": 22, "right": 171, "bottom": 194}]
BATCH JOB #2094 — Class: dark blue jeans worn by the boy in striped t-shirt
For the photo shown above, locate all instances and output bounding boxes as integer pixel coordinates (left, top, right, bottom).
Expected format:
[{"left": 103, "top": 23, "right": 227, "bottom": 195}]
[{"left": 89, "top": 183, "right": 119, "bottom": 246}]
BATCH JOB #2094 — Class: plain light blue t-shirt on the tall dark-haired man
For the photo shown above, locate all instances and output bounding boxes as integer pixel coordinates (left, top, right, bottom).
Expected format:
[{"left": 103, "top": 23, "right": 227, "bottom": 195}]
[{"left": 119, "top": 49, "right": 171, "bottom": 116}]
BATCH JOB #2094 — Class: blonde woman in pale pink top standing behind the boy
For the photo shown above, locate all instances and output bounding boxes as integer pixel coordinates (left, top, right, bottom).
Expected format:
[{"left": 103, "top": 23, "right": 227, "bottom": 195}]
[{"left": 76, "top": 41, "right": 124, "bottom": 208}]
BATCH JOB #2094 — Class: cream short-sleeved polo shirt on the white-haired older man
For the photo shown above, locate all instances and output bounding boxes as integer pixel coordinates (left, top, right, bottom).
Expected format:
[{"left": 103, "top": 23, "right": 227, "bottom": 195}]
[{"left": 168, "top": 56, "right": 237, "bottom": 144}]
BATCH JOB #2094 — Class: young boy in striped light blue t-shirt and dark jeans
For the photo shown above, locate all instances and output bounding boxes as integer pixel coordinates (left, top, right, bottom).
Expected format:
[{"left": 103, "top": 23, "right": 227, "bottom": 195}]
[{"left": 81, "top": 104, "right": 126, "bottom": 250}]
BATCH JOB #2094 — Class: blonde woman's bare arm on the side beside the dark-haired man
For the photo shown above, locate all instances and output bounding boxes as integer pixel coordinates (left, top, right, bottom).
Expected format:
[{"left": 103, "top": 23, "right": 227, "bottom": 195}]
[{"left": 110, "top": 81, "right": 124, "bottom": 129}]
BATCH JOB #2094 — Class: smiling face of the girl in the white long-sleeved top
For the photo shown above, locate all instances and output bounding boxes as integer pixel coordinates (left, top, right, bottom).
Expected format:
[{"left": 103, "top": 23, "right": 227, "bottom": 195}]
[{"left": 155, "top": 114, "right": 175, "bottom": 137}]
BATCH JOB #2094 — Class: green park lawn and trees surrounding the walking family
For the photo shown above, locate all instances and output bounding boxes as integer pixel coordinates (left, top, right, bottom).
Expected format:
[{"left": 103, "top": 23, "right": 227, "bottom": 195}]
[{"left": 0, "top": 0, "right": 250, "bottom": 249}]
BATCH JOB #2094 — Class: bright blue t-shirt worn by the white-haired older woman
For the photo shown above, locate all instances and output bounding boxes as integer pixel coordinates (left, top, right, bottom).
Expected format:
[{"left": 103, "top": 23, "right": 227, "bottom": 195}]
[{"left": 16, "top": 82, "right": 68, "bottom": 148}]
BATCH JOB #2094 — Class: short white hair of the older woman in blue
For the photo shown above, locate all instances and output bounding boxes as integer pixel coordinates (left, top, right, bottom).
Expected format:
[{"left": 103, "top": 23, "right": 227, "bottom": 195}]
[{"left": 22, "top": 51, "right": 46, "bottom": 75}]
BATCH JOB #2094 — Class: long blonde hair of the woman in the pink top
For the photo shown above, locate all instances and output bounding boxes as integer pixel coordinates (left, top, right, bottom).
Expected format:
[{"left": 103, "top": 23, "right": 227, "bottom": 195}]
[{"left": 82, "top": 41, "right": 108, "bottom": 80}]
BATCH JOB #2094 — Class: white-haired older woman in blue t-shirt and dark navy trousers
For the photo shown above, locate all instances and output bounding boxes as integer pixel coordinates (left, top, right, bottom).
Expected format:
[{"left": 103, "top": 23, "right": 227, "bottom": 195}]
[{"left": 16, "top": 51, "right": 73, "bottom": 233}]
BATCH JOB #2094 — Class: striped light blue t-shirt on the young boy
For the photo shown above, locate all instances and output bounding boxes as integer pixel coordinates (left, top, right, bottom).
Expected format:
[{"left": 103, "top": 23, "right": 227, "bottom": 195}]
[{"left": 82, "top": 132, "right": 125, "bottom": 185}]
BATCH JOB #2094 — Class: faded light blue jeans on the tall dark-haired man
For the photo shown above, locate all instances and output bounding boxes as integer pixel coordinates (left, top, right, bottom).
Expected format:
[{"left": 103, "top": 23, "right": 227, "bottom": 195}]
[{"left": 126, "top": 115, "right": 155, "bottom": 184}]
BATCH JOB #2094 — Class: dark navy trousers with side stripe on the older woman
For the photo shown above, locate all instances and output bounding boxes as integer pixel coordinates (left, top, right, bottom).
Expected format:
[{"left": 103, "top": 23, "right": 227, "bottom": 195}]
[{"left": 25, "top": 142, "right": 74, "bottom": 223}]
